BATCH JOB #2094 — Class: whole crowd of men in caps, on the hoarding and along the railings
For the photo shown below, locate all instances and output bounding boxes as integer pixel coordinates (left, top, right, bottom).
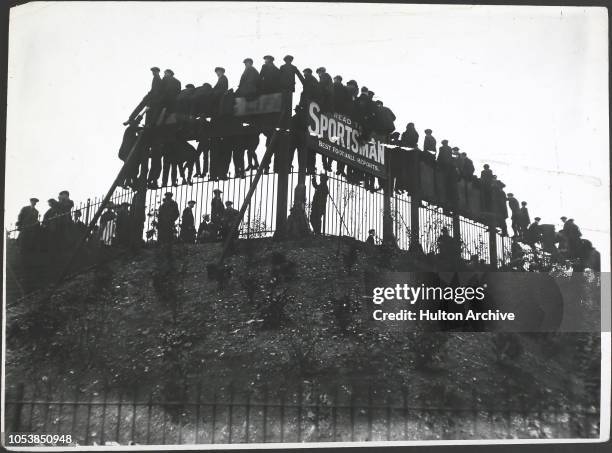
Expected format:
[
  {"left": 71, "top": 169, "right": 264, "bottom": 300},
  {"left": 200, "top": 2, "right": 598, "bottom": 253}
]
[{"left": 11, "top": 55, "right": 590, "bottom": 270}]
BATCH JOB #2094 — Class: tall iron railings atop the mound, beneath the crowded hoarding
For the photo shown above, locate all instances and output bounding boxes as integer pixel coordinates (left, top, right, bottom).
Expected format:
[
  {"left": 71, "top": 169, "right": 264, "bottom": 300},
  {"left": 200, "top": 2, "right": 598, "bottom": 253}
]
[{"left": 7, "top": 170, "right": 510, "bottom": 265}]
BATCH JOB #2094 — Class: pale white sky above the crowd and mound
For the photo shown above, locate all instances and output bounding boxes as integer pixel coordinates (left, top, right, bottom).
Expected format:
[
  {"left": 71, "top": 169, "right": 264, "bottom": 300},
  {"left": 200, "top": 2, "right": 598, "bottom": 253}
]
[{"left": 5, "top": 2, "right": 610, "bottom": 270}]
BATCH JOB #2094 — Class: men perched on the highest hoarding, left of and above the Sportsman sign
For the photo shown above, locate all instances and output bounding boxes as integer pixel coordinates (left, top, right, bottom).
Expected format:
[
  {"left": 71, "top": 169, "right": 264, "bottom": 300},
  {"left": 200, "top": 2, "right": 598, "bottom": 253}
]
[{"left": 119, "top": 55, "right": 402, "bottom": 188}]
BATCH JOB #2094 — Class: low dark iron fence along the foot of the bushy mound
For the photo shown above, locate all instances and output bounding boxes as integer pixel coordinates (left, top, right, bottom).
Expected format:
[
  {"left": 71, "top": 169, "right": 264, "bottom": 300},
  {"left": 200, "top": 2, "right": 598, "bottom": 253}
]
[{"left": 5, "top": 383, "right": 599, "bottom": 445}]
